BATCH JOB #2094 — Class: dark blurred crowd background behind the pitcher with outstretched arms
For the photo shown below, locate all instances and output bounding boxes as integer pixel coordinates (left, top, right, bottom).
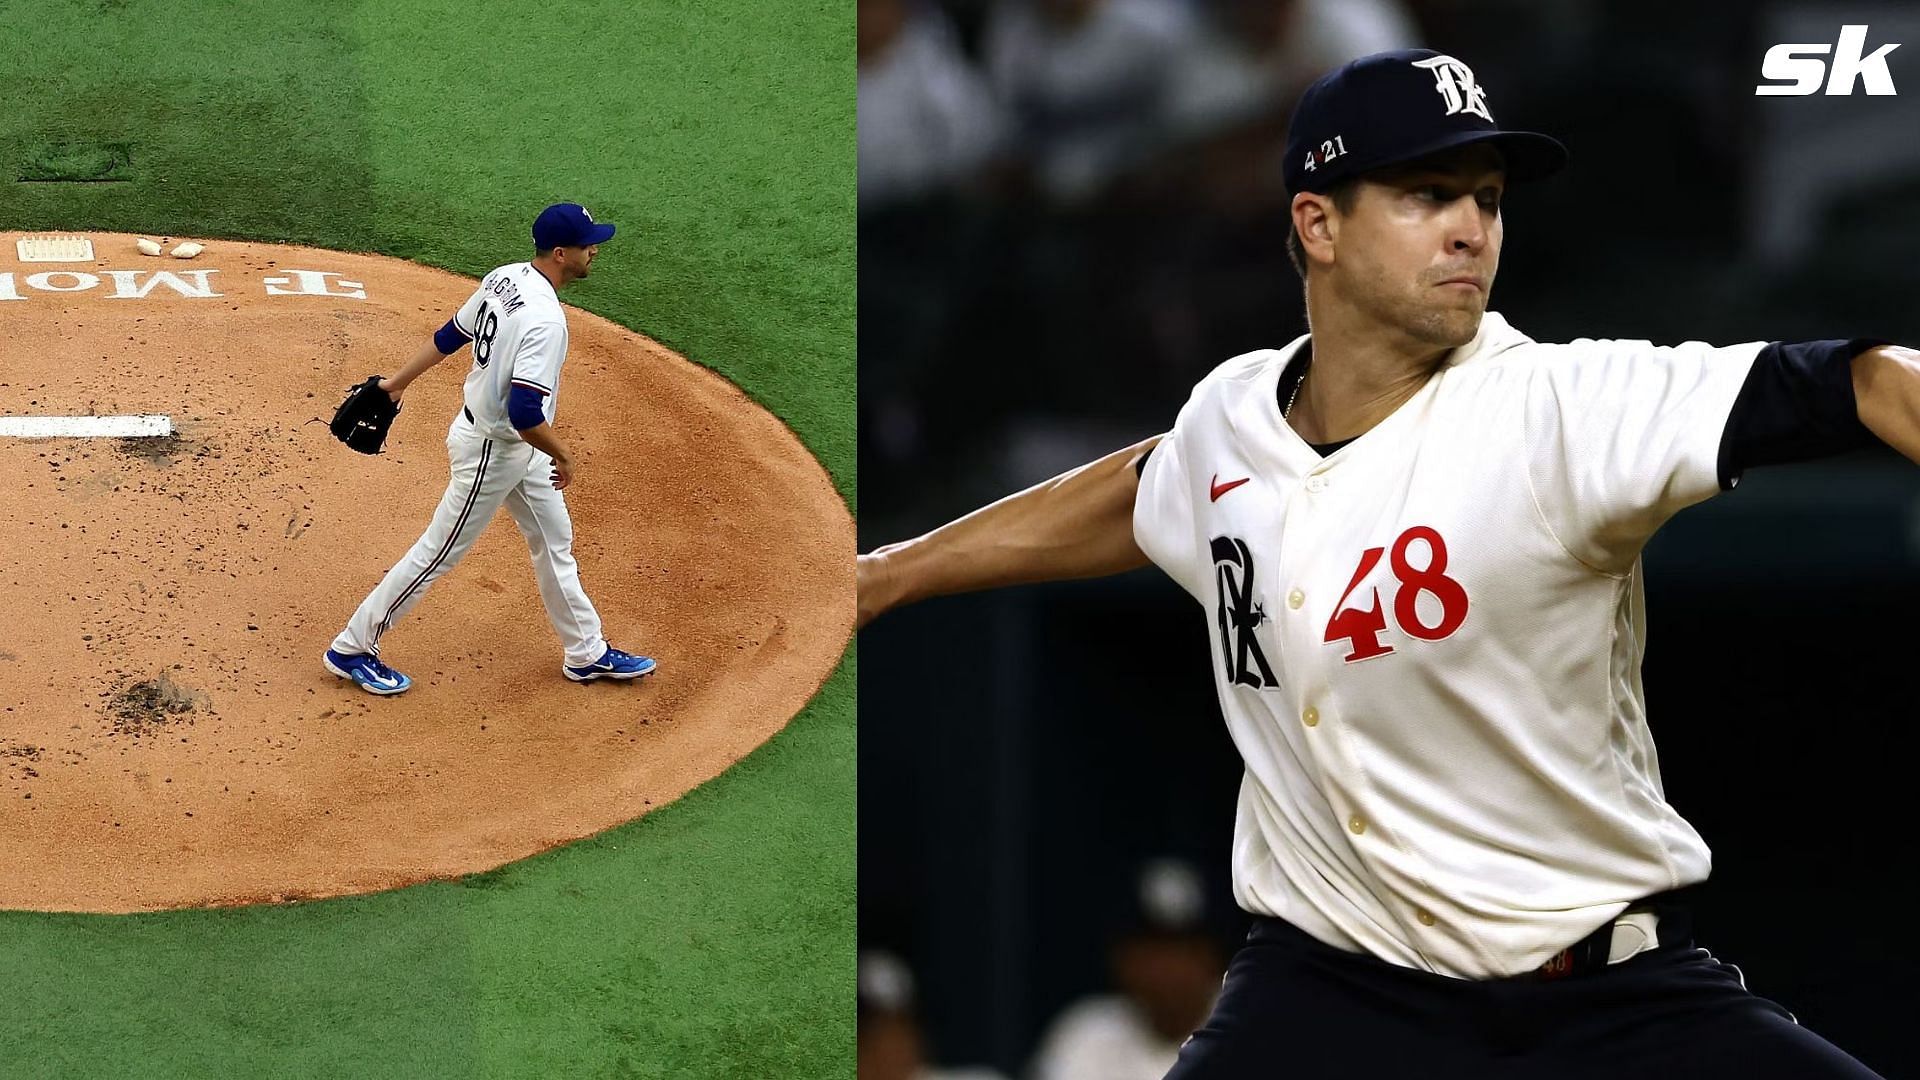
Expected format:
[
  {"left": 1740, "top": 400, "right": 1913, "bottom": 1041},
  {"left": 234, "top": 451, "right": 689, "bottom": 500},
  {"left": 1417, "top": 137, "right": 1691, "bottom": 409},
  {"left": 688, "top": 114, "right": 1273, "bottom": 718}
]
[{"left": 858, "top": 0, "right": 1920, "bottom": 1080}]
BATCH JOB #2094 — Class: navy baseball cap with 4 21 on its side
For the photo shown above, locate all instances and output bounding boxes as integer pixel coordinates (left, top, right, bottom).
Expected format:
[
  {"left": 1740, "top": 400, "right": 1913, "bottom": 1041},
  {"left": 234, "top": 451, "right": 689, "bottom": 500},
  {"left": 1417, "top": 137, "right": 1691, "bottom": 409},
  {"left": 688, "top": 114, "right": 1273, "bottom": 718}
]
[{"left": 1286, "top": 48, "right": 1567, "bottom": 194}]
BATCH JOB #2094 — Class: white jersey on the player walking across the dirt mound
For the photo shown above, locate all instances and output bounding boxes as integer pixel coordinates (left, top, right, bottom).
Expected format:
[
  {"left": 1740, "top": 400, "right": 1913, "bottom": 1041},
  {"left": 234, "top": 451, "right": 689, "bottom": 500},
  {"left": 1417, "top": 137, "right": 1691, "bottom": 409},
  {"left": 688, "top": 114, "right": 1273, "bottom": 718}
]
[{"left": 453, "top": 263, "right": 566, "bottom": 440}]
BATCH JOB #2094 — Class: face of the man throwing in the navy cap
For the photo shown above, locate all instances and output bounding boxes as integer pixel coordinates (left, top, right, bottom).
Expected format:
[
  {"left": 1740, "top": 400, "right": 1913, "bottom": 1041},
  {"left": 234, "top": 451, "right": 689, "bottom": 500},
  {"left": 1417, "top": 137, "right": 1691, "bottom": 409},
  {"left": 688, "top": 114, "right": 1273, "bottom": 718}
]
[{"left": 1332, "top": 144, "right": 1507, "bottom": 348}]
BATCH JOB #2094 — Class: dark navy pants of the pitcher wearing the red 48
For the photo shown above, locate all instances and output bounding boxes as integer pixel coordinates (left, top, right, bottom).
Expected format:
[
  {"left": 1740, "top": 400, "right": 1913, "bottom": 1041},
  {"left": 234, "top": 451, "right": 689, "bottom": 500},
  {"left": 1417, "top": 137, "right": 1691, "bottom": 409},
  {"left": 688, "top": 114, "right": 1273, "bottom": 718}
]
[{"left": 1167, "top": 903, "right": 1878, "bottom": 1080}]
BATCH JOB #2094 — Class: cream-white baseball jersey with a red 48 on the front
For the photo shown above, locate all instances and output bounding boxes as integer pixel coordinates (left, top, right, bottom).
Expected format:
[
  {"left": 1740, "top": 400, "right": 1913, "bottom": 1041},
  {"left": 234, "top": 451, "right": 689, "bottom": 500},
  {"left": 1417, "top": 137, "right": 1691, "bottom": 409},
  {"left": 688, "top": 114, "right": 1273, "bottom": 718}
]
[{"left": 1133, "top": 311, "right": 1764, "bottom": 978}]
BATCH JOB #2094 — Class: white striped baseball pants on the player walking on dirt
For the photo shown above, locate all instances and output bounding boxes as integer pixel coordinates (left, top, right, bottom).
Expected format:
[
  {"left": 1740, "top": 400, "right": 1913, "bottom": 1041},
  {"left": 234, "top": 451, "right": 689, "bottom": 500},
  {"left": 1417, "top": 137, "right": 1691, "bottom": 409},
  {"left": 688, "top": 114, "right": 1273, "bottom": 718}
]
[{"left": 334, "top": 409, "right": 607, "bottom": 667}]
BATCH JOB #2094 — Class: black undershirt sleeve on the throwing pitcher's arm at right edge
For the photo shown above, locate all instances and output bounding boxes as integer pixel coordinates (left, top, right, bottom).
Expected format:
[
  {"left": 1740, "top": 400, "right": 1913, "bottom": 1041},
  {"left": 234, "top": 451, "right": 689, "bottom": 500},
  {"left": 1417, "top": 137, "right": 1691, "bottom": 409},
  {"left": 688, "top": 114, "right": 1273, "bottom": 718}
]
[{"left": 1720, "top": 338, "right": 1891, "bottom": 490}]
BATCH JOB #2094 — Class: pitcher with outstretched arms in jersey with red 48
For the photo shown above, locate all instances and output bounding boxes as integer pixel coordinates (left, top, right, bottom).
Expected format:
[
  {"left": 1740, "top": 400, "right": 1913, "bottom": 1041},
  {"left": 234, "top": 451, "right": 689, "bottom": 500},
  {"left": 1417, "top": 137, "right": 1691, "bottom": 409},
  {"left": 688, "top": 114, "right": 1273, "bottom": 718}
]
[{"left": 858, "top": 50, "right": 1920, "bottom": 1080}]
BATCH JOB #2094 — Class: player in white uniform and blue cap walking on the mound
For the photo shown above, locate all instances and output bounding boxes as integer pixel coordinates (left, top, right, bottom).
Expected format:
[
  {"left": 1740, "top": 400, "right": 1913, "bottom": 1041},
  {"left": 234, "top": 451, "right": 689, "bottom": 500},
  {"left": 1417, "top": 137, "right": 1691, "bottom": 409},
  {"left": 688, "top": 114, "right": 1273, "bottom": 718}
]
[{"left": 321, "top": 204, "right": 655, "bottom": 696}]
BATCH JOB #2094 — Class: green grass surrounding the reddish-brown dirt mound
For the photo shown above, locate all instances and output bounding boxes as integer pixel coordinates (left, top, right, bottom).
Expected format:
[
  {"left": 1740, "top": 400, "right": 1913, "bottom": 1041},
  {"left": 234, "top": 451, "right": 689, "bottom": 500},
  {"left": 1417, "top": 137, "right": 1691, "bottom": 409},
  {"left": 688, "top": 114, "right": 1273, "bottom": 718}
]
[{"left": 0, "top": 0, "right": 858, "bottom": 1078}]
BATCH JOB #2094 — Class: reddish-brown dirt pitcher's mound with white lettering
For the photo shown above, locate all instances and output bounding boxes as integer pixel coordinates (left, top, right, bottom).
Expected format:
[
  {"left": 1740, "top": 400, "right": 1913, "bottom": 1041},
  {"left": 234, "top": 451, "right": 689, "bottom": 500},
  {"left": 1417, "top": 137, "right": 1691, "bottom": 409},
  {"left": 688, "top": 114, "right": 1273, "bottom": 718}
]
[{"left": 0, "top": 233, "right": 854, "bottom": 911}]
